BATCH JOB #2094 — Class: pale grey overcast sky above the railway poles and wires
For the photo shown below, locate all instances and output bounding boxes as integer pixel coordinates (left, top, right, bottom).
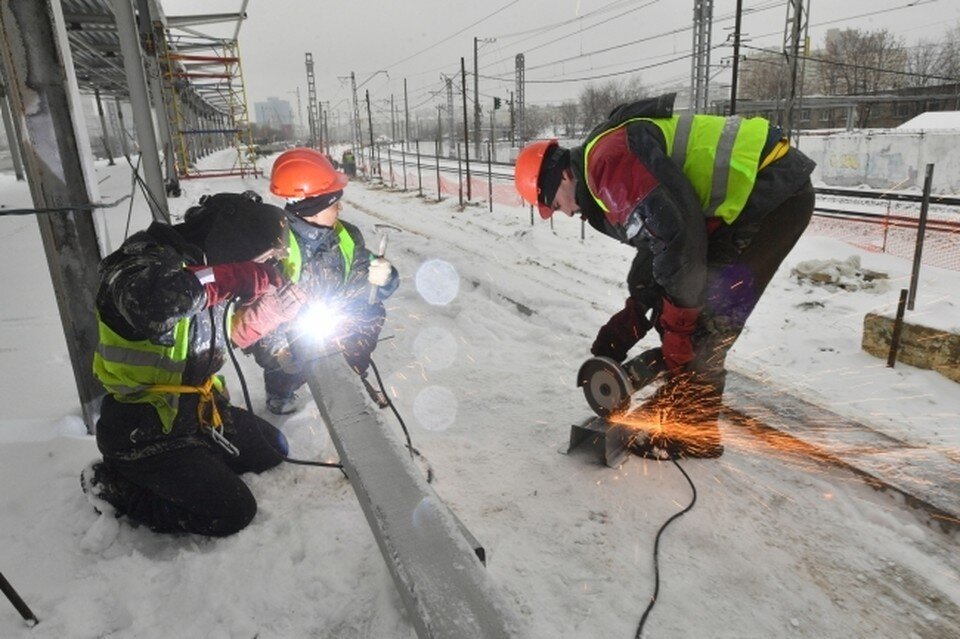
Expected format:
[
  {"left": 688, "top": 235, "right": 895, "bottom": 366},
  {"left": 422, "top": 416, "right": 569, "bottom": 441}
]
[{"left": 160, "top": 0, "right": 960, "bottom": 127}]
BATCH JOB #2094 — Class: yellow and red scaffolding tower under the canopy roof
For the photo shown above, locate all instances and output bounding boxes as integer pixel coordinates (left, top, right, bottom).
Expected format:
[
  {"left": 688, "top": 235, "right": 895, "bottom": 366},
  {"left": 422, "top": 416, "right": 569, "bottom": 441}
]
[{"left": 158, "top": 37, "right": 263, "bottom": 179}]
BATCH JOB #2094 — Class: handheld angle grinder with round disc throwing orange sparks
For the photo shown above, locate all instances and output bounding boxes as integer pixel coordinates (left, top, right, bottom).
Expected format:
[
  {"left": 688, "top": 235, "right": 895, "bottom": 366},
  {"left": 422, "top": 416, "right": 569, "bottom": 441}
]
[{"left": 577, "top": 348, "right": 666, "bottom": 417}]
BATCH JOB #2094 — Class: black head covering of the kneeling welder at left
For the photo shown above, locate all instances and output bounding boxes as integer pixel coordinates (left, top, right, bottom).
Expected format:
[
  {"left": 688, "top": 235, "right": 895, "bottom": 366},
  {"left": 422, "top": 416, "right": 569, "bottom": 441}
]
[{"left": 184, "top": 193, "right": 288, "bottom": 265}]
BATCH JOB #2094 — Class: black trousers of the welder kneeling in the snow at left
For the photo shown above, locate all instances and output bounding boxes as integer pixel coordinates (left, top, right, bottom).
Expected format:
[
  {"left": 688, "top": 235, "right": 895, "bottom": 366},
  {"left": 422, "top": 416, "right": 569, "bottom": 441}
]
[{"left": 97, "top": 398, "right": 288, "bottom": 537}]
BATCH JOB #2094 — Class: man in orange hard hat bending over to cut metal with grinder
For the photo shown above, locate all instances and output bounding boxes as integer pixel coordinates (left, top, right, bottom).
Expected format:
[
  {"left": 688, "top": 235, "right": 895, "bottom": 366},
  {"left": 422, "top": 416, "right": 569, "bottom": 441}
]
[{"left": 514, "top": 94, "right": 815, "bottom": 457}]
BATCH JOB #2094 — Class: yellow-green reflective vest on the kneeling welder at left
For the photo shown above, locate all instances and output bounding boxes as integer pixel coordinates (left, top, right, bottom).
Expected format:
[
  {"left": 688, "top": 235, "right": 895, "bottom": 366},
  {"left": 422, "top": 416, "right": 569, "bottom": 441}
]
[{"left": 93, "top": 313, "right": 190, "bottom": 433}]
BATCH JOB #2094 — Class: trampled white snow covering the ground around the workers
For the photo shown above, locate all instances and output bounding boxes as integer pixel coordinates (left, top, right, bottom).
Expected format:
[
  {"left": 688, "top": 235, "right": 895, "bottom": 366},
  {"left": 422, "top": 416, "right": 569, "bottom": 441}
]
[{"left": 0, "top": 151, "right": 960, "bottom": 638}]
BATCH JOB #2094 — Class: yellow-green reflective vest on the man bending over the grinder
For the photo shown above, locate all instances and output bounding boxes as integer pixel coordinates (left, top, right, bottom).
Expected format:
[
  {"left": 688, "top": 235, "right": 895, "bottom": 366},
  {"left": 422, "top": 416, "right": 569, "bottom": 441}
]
[{"left": 584, "top": 115, "right": 769, "bottom": 224}]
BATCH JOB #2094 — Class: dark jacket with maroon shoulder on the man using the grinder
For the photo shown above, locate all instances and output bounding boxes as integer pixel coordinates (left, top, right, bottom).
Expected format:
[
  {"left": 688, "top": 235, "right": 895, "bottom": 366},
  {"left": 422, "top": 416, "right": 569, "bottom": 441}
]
[{"left": 571, "top": 98, "right": 815, "bottom": 307}]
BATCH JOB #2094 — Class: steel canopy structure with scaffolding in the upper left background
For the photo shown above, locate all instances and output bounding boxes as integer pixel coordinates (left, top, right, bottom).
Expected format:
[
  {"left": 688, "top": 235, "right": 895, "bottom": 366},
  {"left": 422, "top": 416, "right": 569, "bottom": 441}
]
[{"left": 61, "top": 0, "right": 260, "bottom": 185}]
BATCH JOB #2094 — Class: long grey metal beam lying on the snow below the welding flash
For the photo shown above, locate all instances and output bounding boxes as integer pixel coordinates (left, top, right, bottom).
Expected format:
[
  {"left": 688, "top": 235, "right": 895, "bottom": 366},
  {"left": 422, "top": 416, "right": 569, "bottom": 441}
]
[{"left": 304, "top": 350, "right": 519, "bottom": 639}]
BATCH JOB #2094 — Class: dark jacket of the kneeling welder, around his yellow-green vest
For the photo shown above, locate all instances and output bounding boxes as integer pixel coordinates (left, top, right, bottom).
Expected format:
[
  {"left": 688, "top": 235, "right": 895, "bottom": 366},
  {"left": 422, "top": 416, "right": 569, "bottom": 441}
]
[{"left": 96, "top": 222, "right": 226, "bottom": 459}]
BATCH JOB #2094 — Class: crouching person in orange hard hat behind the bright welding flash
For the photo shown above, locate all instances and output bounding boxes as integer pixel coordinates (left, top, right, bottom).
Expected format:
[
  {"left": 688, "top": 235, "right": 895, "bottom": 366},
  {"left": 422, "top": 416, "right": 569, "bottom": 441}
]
[{"left": 250, "top": 148, "right": 400, "bottom": 415}]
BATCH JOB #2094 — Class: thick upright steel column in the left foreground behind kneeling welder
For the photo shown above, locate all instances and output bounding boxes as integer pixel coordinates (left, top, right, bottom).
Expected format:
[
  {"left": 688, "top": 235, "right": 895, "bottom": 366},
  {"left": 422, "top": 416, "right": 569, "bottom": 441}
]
[{"left": 0, "top": 0, "right": 104, "bottom": 432}]
